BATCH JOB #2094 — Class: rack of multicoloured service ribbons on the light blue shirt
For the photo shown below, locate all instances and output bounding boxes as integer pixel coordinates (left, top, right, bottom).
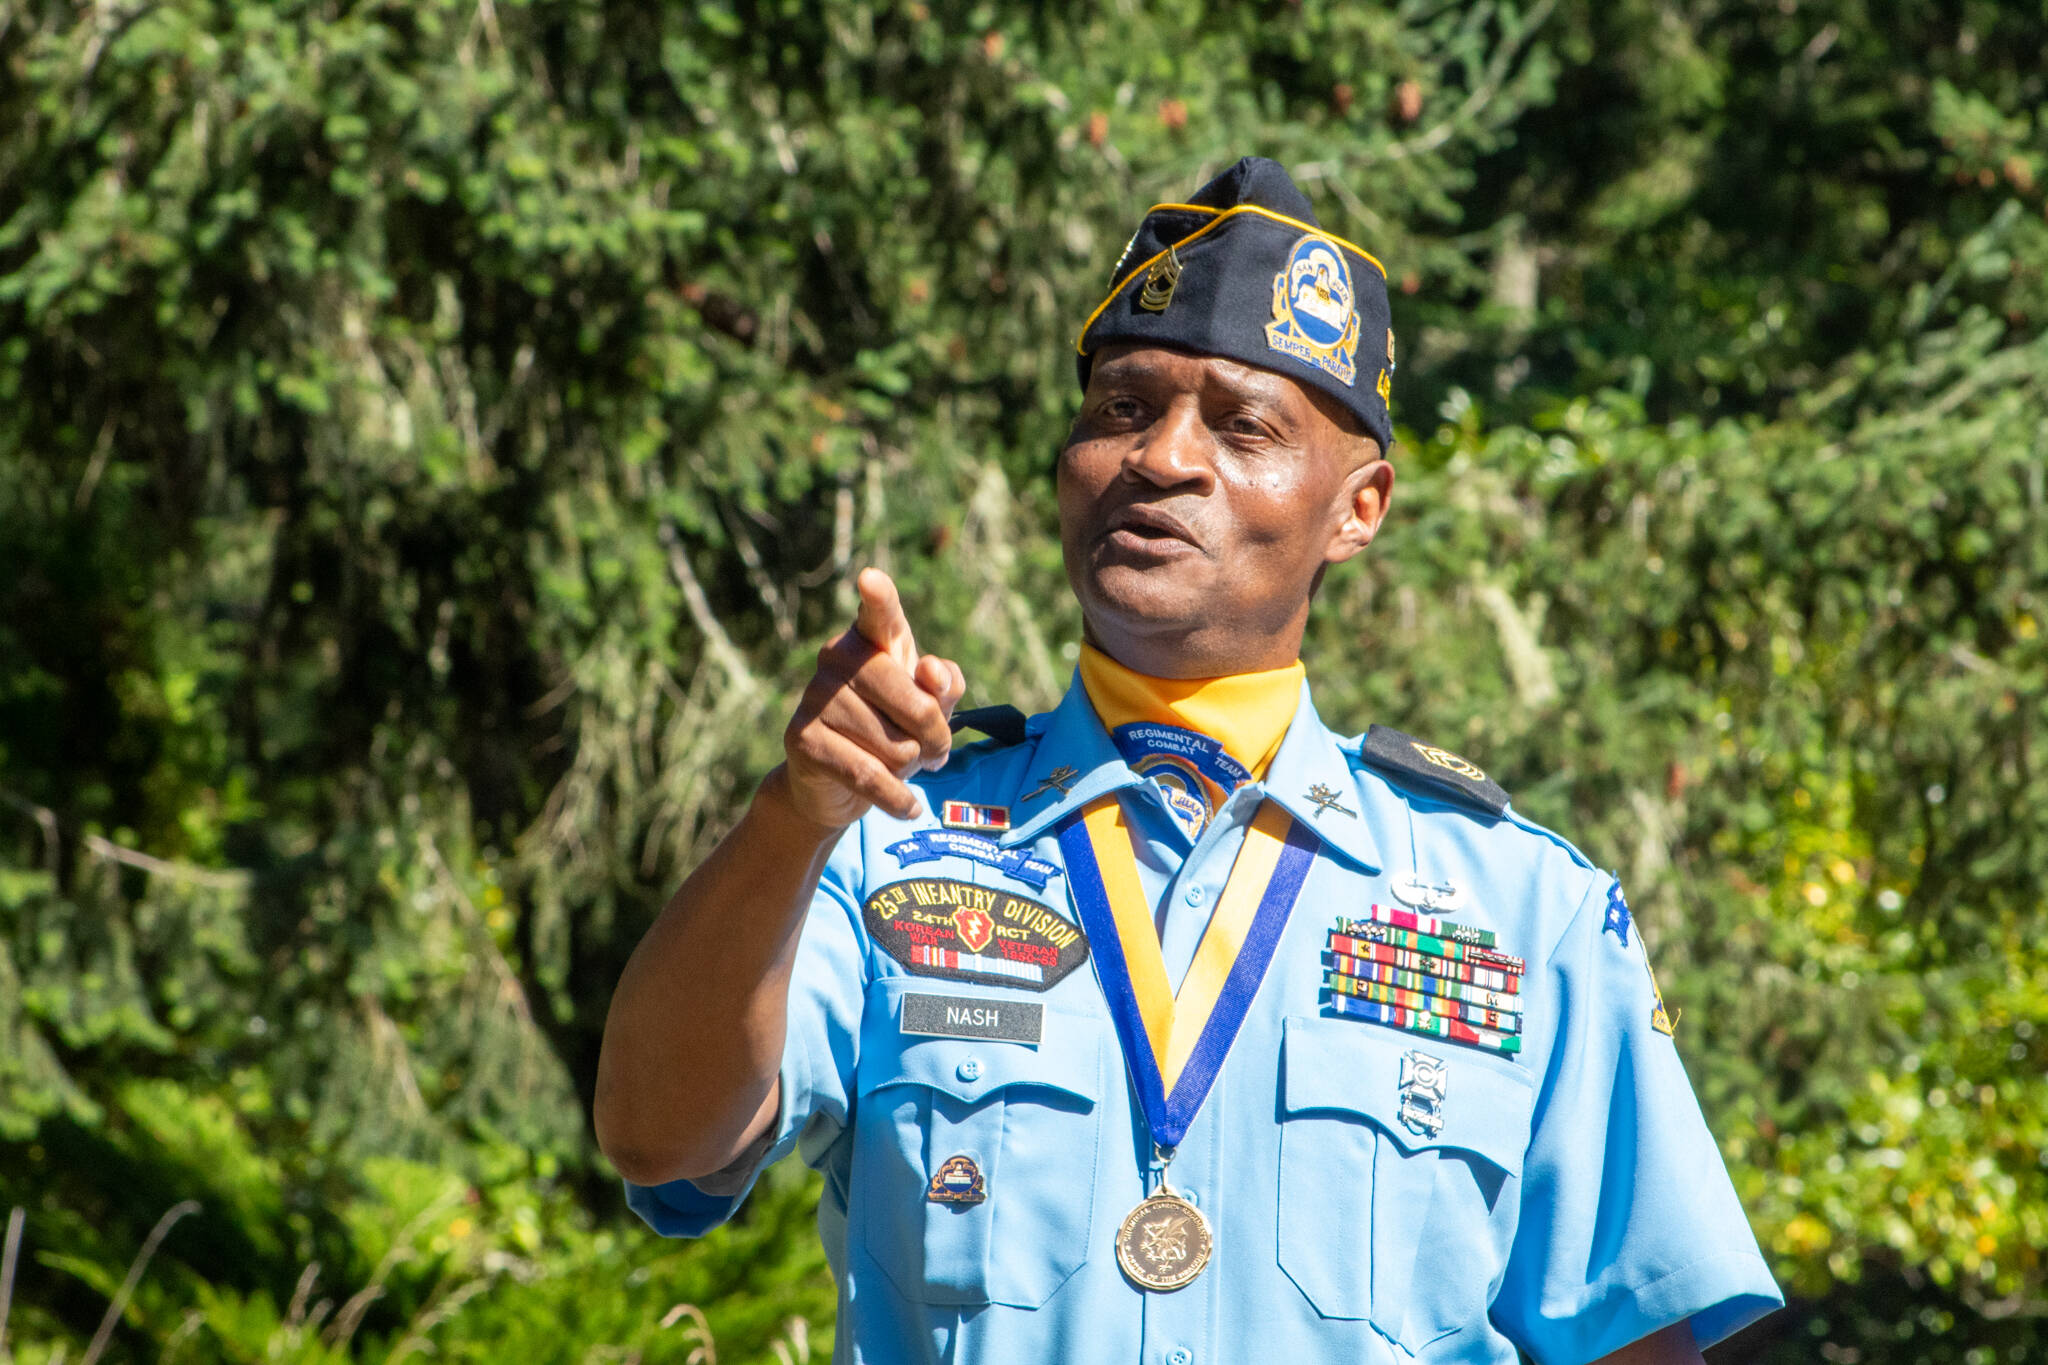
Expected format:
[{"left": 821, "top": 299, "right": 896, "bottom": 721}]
[{"left": 1323, "top": 905, "right": 1526, "bottom": 1058}]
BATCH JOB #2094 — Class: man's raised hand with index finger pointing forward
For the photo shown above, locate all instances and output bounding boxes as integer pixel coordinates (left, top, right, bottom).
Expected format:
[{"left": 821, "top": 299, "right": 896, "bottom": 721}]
[{"left": 782, "top": 569, "right": 967, "bottom": 829}]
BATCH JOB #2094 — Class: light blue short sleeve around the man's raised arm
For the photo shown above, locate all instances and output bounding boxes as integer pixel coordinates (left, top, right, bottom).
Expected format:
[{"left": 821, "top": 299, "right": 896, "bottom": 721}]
[{"left": 625, "top": 825, "right": 870, "bottom": 1236}]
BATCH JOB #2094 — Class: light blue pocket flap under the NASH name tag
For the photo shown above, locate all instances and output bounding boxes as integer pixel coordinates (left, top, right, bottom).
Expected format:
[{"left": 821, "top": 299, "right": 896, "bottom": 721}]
[{"left": 856, "top": 980, "right": 1106, "bottom": 1105}]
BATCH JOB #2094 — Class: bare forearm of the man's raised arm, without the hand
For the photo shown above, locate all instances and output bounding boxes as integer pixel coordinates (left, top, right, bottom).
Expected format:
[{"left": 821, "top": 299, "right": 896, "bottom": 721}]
[{"left": 594, "top": 769, "right": 840, "bottom": 1185}]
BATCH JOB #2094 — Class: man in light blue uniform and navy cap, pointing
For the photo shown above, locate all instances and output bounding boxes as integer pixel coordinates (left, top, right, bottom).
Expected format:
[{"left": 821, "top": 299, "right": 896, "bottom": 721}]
[{"left": 596, "top": 160, "right": 1780, "bottom": 1365}]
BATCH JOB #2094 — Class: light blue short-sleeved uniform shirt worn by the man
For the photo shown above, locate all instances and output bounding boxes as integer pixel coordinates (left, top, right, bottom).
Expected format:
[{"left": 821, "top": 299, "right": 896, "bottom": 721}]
[{"left": 627, "top": 681, "right": 1782, "bottom": 1365}]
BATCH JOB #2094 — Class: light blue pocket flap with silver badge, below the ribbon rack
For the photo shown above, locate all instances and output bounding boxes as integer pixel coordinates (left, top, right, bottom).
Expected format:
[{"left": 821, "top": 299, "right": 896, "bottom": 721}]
[{"left": 1280, "top": 1015, "right": 1536, "bottom": 1177}]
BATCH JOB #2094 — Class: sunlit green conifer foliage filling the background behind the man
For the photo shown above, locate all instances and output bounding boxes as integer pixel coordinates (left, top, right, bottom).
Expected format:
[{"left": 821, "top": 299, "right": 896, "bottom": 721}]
[{"left": 0, "top": 0, "right": 2048, "bottom": 1365}]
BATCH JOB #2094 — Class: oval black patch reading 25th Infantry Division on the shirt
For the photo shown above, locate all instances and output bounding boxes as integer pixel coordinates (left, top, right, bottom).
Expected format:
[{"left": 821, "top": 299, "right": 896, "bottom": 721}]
[{"left": 860, "top": 876, "right": 1087, "bottom": 990}]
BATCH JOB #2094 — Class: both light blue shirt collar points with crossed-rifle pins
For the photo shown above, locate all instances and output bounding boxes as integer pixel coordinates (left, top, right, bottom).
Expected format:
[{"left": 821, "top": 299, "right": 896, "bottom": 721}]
[{"left": 999, "top": 671, "right": 1382, "bottom": 872}]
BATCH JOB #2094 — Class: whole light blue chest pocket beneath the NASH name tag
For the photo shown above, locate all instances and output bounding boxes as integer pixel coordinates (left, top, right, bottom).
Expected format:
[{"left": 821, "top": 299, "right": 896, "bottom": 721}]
[{"left": 848, "top": 978, "right": 1104, "bottom": 1308}]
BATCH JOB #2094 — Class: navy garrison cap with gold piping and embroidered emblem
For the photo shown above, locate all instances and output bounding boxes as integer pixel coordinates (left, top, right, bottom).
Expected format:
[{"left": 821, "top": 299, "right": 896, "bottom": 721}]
[{"left": 1079, "top": 156, "right": 1395, "bottom": 450}]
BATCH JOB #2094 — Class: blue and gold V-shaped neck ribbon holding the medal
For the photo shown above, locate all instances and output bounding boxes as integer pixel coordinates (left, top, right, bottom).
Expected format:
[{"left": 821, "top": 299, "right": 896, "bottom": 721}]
[{"left": 1059, "top": 792, "right": 1315, "bottom": 1148}]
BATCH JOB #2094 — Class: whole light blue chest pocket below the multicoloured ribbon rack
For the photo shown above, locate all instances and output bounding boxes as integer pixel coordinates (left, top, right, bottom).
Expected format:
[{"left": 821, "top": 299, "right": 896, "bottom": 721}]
[{"left": 1280, "top": 1017, "right": 1534, "bottom": 1353}]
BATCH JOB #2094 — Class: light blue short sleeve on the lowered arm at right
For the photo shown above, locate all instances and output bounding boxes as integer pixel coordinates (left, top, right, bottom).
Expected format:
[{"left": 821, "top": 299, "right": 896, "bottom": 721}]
[{"left": 1493, "top": 880, "right": 1784, "bottom": 1365}]
